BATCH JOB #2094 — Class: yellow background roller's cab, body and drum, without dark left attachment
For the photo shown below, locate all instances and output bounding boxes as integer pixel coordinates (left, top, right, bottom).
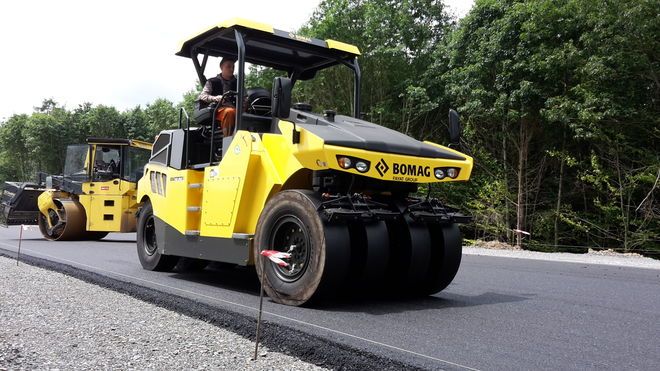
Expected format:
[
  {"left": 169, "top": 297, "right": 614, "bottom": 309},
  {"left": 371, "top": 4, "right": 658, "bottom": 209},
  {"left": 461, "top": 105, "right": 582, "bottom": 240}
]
[{"left": 37, "top": 138, "right": 151, "bottom": 240}]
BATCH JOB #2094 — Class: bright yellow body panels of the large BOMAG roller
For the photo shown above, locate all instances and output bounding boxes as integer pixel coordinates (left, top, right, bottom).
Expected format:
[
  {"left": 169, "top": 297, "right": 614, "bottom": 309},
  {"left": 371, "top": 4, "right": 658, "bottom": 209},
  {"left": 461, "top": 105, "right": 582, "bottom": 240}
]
[{"left": 138, "top": 121, "right": 473, "bottom": 243}]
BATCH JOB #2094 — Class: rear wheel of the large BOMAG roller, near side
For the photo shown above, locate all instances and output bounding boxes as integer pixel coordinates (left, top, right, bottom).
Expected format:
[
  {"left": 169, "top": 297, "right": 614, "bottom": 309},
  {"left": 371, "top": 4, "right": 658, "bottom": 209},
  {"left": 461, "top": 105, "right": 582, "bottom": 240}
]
[{"left": 137, "top": 201, "right": 179, "bottom": 272}]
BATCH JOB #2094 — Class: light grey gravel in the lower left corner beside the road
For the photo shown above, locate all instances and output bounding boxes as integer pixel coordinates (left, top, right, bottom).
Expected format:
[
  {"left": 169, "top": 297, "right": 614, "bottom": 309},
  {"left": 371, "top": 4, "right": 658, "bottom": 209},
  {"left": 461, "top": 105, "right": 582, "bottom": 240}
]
[{"left": 0, "top": 257, "right": 323, "bottom": 370}]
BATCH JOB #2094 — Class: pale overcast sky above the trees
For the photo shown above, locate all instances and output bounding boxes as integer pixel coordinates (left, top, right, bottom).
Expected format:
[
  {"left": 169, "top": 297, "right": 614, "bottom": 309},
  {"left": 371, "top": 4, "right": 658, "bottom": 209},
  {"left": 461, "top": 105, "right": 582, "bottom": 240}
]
[{"left": 0, "top": 0, "right": 473, "bottom": 120}]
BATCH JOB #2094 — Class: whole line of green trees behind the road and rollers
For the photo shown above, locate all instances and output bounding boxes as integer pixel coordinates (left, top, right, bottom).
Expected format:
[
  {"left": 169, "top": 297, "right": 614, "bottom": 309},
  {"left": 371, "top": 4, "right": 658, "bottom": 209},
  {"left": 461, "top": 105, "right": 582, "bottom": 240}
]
[{"left": 0, "top": 0, "right": 660, "bottom": 255}]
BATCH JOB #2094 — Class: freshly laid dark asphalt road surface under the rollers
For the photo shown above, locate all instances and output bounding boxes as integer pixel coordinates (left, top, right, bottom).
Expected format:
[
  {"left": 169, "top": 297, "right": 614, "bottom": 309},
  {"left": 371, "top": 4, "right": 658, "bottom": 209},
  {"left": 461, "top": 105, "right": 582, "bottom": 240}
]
[{"left": 0, "top": 227, "right": 660, "bottom": 370}]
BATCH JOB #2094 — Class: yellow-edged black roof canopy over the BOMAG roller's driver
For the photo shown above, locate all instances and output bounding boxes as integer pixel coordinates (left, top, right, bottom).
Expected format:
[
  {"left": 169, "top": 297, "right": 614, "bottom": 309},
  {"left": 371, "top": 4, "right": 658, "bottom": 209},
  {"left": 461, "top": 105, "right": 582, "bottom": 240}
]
[{"left": 176, "top": 18, "right": 360, "bottom": 79}]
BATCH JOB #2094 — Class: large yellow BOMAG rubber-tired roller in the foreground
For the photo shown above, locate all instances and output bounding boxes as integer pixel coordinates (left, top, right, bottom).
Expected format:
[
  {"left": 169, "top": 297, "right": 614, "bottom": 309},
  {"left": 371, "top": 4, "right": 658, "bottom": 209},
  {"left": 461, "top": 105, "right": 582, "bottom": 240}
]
[{"left": 137, "top": 19, "right": 472, "bottom": 305}]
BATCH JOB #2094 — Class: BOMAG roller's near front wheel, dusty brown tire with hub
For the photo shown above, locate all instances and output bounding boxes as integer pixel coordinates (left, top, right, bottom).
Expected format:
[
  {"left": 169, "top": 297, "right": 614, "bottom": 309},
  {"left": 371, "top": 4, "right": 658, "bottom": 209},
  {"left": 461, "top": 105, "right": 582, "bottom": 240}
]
[{"left": 253, "top": 190, "right": 350, "bottom": 306}]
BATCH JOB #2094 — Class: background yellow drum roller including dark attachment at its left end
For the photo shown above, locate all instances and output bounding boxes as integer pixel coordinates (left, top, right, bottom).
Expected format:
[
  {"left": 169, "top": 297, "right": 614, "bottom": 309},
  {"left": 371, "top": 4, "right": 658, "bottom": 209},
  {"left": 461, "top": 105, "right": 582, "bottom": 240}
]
[{"left": 0, "top": 138, "right": 151, "bottom": 240}]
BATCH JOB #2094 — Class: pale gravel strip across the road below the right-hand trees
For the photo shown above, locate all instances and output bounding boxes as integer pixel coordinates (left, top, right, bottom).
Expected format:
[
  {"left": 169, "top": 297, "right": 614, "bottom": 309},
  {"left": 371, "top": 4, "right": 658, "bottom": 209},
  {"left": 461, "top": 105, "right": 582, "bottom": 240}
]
[{"left": 463, "top": 246, "right": 660, "bottom": 269}]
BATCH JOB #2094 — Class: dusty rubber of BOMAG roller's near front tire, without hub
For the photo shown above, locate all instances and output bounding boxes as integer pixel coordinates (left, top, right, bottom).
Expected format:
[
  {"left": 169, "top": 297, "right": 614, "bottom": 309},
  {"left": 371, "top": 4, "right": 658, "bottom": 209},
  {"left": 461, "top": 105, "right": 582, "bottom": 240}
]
[{"left": 253, "top": 190, "right": 350, "bottom": 306}]
